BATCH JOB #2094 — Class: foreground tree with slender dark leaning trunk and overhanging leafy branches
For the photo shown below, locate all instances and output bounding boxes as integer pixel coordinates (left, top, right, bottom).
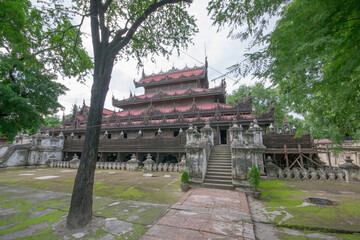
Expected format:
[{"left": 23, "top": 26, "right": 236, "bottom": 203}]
[{"left": 63, "top": 0, "right": 197, "bottom": 228}]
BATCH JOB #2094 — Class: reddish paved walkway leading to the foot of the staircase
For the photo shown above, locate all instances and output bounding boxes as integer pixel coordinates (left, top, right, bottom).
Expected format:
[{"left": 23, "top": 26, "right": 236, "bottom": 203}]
[{"left": 141, "top": 188, "right": 255, "bottom": 240}]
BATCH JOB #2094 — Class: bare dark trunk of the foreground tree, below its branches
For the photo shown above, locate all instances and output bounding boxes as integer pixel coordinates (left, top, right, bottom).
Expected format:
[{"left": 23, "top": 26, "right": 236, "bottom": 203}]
[{"left": 67, "top": 55, "right": 113, "bottom": 229}]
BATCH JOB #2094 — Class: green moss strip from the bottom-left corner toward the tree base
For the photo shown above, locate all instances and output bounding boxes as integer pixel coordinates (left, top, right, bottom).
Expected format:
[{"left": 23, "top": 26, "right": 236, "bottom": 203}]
[{"left": 0, "top": 211, "right": 66, "bottom": 235}]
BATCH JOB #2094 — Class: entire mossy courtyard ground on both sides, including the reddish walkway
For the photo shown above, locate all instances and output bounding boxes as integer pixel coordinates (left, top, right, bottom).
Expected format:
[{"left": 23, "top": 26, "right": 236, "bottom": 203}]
[{"left": 0, "top": 169, "right": 360, "bottom": 240}]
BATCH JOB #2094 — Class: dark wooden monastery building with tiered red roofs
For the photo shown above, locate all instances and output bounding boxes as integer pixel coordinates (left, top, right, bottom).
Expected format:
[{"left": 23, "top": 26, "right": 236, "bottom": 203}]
[{"left": 48, "top": 63, "right": 318, "bottom": 168}]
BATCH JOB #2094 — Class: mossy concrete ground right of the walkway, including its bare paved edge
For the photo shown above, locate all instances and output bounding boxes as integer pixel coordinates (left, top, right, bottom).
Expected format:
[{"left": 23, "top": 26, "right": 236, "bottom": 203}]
[{"left": 248, "top": 180, "right": 360, "bottom": 239}]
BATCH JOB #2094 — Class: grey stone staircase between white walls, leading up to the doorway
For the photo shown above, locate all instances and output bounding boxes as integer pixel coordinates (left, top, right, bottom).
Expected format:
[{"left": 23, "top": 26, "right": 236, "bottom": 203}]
[{"left": 203, "top": 145, "right": 234, "bottom": 189}]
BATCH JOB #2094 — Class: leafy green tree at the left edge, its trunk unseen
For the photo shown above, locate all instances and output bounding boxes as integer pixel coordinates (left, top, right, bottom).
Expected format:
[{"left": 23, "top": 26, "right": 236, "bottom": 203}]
[{"left": 0, "top": 0, "right": 92, "bottom": 139}]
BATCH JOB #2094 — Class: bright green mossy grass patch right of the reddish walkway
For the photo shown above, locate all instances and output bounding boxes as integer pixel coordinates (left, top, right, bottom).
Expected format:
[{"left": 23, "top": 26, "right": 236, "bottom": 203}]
[{"left": 260, "top": 180, "right": 360, "bottom": 232}]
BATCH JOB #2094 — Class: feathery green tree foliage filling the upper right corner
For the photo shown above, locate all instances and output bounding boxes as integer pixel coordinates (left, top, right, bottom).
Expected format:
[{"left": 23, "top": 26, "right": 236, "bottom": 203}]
[{"left": 208, "top": 0, "right": 360, "bottom": 141}]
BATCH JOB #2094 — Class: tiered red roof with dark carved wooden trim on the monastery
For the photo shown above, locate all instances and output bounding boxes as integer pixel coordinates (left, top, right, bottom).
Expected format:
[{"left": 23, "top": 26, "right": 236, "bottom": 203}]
[{"left": 55, "top": 64, "right": 274, "bottom": 129}]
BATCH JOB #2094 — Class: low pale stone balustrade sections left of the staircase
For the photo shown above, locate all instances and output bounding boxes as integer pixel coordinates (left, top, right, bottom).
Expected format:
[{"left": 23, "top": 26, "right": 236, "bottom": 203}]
[{"left": 50, "top": 161, "right": 186, "bottom": 172}]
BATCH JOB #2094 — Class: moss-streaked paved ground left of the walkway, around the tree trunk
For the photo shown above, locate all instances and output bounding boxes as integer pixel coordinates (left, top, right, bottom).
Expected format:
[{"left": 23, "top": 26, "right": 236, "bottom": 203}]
[{"left": 0, "top": 169, "right": 183, "bottom": 239}]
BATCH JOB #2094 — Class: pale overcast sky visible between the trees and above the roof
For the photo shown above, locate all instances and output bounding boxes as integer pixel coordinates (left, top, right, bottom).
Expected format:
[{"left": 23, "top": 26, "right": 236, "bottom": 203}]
[{"left": 58, "top": 0, "right": 254, "bottom": 115}]
